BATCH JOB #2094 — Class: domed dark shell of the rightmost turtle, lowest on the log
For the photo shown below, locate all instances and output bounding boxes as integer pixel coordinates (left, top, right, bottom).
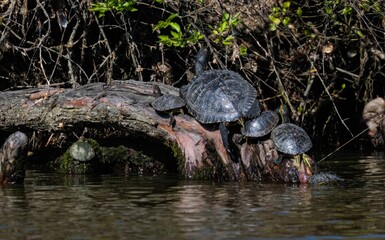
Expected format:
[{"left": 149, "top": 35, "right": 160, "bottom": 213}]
[{"left": 271, "top": 123, "right": 313, "bottom": 155}]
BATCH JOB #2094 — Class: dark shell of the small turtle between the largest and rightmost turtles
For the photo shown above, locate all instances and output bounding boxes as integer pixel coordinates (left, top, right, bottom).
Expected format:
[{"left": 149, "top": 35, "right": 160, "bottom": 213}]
[{"left": 242, "top": 110, "right": 279, "bottom": 137}]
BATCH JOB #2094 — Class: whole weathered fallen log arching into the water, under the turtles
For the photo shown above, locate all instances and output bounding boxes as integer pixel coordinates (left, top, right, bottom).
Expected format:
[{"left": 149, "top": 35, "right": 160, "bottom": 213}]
[{"left": 0, "top": 80, "right": 312, "bottom": 181}]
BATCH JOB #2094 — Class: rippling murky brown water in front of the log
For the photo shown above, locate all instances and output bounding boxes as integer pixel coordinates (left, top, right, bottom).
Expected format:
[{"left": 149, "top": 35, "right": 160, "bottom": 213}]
[{"left": 0, "top": 153, "right": 385, "bottom": 239}]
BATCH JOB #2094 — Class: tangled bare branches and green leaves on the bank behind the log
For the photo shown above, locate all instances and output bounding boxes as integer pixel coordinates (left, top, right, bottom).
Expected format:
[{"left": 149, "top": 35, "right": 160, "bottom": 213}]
[{"left": 0, "top": 0, "right": 385, "bottom": 146}]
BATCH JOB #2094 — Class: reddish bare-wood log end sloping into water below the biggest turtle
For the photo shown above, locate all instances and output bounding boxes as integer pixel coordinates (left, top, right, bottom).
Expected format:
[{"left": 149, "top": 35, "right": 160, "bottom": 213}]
[{"left": 157, "top": 115, "right": 237, "bottom": 180}]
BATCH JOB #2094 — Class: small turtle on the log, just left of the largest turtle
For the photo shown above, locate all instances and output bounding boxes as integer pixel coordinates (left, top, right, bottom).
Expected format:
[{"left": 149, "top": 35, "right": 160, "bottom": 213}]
[{"left": 151, "top": 85, "right": 185, "bottom": 126}]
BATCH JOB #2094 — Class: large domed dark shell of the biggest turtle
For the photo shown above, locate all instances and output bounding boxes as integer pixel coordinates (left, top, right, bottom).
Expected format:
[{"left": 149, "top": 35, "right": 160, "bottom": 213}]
[{"left": 181, "top": 70, "right": 257, "bottom": 123}]
